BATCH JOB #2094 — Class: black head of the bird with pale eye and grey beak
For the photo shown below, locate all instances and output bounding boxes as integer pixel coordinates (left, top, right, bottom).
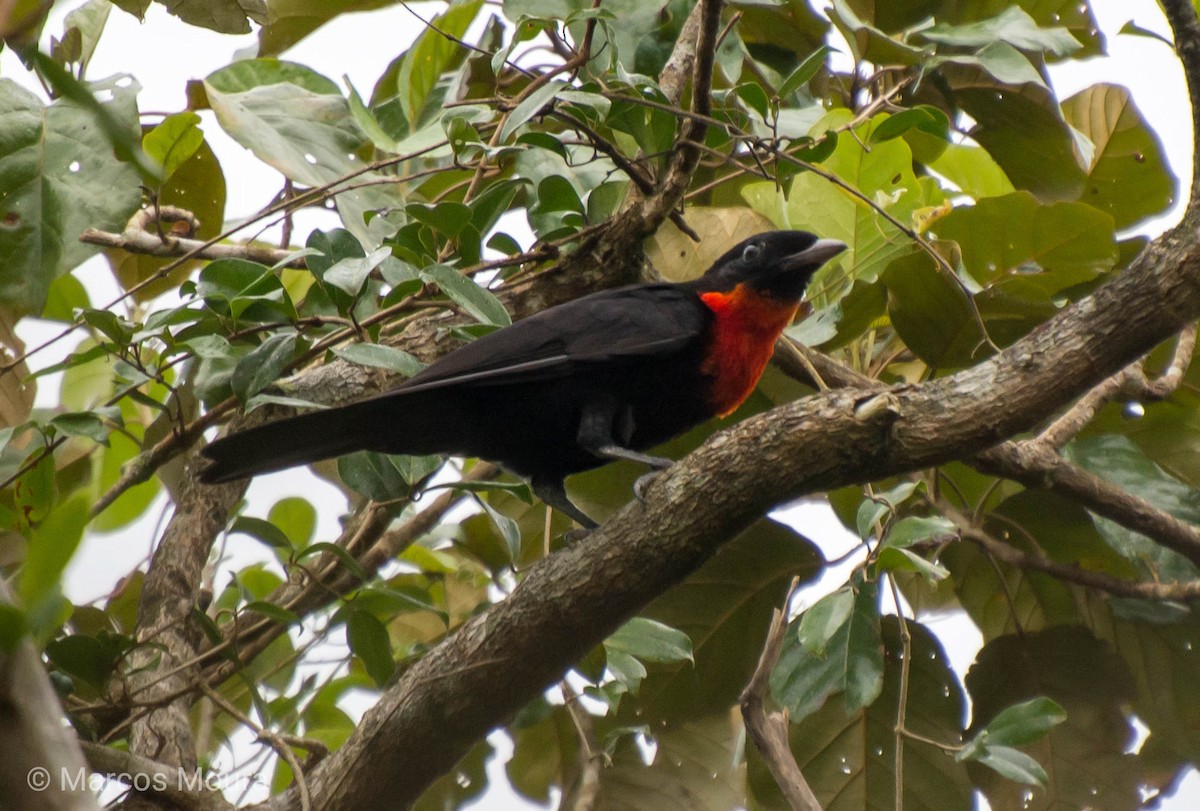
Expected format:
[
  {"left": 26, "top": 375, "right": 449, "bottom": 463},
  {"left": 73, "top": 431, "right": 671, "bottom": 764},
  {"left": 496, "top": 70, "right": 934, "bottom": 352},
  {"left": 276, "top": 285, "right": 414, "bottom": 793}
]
[{"left": 700, "top": 230, "right": 846, "bottom": 301}]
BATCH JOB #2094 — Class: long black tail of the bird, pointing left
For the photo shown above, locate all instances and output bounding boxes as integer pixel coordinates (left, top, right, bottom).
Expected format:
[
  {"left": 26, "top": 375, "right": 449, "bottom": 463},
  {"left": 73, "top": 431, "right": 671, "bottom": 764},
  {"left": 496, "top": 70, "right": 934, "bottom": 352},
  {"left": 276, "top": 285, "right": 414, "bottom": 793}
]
[{"left": 200, "top": 403, "right": 393, "bottom": 485}]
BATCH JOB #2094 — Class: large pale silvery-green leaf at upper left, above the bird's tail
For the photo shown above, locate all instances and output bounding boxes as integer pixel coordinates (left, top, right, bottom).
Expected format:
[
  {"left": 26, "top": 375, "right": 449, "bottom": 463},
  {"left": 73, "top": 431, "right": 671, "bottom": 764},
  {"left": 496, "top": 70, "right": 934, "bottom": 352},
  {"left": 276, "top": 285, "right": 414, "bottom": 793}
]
[{"left": 204, "top": 59, "right": 403, "bottom": 247}]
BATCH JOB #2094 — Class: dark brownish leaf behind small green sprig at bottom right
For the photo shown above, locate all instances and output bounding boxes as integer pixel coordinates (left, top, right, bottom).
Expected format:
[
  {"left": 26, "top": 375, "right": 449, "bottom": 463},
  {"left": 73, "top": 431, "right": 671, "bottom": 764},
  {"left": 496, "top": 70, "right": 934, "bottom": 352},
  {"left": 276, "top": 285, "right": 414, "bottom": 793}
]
[{"left": 966, "top": 626, "right": 1140, "bottom": 811}]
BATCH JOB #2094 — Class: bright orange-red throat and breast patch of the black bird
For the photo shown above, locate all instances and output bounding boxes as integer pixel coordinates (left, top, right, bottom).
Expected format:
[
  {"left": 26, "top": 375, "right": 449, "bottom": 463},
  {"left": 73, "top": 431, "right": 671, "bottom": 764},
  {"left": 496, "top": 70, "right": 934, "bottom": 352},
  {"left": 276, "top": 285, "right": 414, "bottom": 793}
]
[{"left": 700, "top": 284, "right": 800, "bottom": 416}]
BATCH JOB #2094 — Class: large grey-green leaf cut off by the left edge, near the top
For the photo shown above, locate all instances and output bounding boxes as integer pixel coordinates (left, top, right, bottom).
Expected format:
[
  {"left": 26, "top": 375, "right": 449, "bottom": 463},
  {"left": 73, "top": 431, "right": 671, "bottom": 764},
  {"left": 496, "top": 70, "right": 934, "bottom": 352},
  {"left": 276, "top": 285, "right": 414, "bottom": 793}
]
[{"left": 0, "top": 79, "right": 142, "bottom": 313}]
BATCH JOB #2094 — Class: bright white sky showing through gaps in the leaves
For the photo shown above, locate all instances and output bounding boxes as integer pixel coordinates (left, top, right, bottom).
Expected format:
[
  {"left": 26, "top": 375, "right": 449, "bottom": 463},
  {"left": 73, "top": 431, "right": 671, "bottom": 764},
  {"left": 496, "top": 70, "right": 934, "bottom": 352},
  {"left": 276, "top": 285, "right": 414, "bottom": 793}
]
[{"left": 0, "top": 0, "right": 1200, "bottom": 811}]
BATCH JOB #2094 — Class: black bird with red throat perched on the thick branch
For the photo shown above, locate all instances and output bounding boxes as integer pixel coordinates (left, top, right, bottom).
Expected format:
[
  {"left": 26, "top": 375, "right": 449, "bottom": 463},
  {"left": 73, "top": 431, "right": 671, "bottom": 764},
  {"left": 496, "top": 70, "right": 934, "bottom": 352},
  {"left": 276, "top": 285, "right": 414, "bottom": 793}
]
[{"left": 200, "top": 230, "right": 846, "bottom": 529}]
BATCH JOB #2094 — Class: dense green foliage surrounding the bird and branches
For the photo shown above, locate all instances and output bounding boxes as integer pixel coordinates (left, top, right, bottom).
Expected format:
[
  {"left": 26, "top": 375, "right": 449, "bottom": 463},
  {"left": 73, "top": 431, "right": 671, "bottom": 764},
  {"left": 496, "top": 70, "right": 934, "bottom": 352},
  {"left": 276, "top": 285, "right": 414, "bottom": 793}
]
[{"left": 0, "top": 0, "right": 1200, "bottom": 810}]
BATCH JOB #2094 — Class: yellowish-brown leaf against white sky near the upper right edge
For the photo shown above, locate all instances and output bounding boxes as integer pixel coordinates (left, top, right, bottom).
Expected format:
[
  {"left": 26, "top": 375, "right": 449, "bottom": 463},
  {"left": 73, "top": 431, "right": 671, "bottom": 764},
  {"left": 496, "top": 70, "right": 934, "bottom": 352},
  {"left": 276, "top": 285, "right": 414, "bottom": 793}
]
[{"left": 1062, "top": 84, "right": 1178, "bottom": 229}]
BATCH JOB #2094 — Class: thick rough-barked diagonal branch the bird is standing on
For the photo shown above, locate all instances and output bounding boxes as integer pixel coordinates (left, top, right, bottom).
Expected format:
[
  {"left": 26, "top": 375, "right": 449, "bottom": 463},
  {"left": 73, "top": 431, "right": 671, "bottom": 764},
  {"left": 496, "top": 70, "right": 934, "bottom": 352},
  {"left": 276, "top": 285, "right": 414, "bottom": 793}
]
[{"left": 288, "top": 196, "right": 1200, "bottom": 811}]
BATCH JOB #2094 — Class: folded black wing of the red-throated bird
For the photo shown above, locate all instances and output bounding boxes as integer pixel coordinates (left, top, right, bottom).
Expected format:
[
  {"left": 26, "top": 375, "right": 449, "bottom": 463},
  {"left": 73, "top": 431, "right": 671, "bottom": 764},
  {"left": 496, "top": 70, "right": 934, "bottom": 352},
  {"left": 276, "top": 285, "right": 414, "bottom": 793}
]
[{"left": 379, "top": 284, "right": 712, "bottom": 397}]
